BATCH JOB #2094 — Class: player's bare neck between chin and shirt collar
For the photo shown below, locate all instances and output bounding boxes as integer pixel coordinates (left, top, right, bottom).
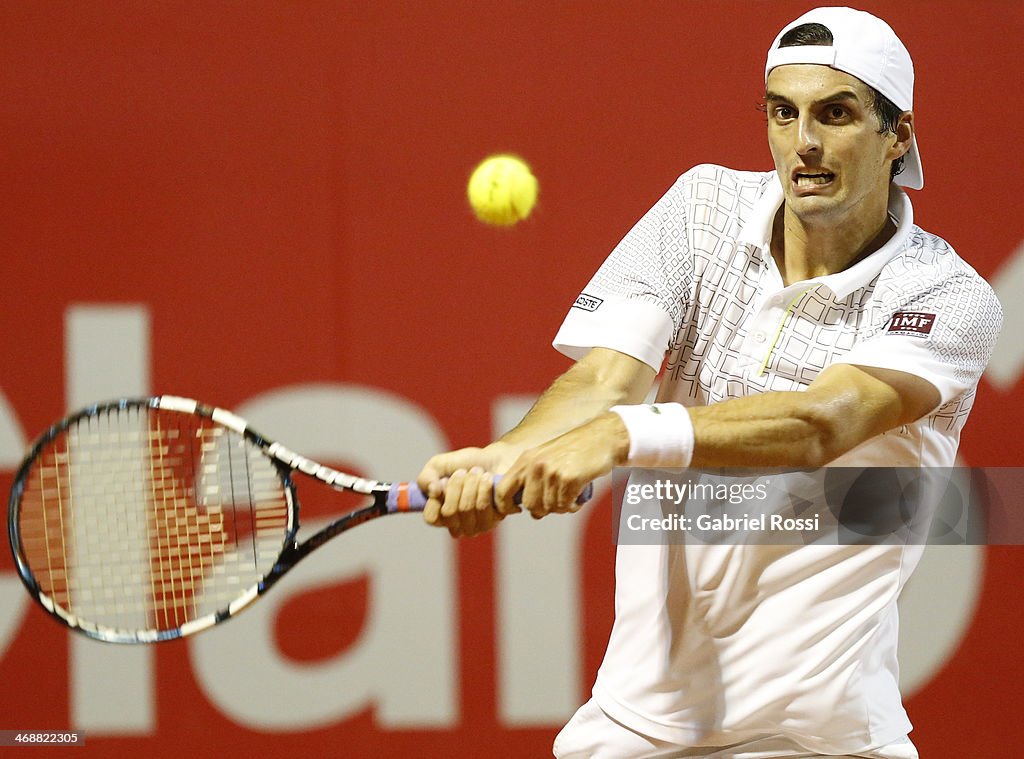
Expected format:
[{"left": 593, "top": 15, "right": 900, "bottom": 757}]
[{"left": 771, "top": 189, "right": 896, "bottom": 285}]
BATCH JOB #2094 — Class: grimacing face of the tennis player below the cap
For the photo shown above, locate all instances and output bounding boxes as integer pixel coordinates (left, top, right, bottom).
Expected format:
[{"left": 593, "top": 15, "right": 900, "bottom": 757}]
[{"left": 765, "top": 64, "right": 906, "bottom": 224}]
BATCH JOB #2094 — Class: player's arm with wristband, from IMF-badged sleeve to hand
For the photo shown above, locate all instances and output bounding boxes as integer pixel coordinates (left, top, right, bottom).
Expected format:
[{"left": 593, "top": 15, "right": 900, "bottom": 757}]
[{"left": 509, "top": 267, "right": 1002, "bottom": 515}]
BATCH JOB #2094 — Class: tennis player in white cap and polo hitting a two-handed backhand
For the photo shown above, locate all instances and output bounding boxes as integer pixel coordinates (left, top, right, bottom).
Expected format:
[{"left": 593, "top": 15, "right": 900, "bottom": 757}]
[{"left": 419, "top": 8, "right": 1001, "bottom": 759}]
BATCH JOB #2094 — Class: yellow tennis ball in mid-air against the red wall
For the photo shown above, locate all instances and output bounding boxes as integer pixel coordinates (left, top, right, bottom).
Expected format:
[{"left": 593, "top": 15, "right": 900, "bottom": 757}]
[{"left": 466, "top": 156, "right": 538, "bottom": 226}]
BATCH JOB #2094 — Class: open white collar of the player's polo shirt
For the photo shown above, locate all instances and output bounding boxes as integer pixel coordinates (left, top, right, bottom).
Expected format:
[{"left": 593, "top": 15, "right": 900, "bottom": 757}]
[{"left": 737, "top": 171, "right": 913, "bottom": 298}]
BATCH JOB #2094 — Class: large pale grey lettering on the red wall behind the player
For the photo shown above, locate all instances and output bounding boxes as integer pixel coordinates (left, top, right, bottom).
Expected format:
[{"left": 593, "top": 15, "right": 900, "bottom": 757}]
[{"left": 0, "top": 309, "right": 999, "bottom": 735}]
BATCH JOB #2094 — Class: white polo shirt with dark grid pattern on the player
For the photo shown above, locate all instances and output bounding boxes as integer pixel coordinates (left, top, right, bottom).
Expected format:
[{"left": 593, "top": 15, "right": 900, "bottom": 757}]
[{"left": 554, "top": 165, "right": 1001, "bottom": 754}]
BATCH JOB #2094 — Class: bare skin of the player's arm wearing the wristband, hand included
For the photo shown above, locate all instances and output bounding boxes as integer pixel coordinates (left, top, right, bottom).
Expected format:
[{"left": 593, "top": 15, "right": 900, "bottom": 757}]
[{"left": 506, "top": 365, "right": 940, "bottom": 516}]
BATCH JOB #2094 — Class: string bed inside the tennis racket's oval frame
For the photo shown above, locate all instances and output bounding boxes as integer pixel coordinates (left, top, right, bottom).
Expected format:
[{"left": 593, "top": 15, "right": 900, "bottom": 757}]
[{"left": 18, "top": 408, "right": 291, "bottom": 631}]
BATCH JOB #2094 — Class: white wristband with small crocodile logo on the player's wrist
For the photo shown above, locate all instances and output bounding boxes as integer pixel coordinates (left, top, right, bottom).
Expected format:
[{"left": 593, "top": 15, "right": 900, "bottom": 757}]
[{"left": 609, "top": 404, "right": 693, "bottom": 468}]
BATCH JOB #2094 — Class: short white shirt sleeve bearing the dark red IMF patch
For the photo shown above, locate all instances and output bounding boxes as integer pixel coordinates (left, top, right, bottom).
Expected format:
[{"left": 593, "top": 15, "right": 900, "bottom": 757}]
[{"left": 838, "top": 270, "right": 1002, "bottom": 405}]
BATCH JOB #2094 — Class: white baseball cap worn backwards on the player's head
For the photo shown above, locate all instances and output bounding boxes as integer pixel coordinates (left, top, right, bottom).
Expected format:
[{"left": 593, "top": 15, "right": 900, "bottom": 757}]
[{"left": 765, "top": 8, "right": 925, "bottom": 189}]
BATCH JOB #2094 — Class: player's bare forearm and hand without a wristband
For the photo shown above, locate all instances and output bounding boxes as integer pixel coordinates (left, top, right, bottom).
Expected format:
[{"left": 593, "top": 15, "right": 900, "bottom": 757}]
[{"left": 417, "top": 348, "right": 655, "bottom": 537}]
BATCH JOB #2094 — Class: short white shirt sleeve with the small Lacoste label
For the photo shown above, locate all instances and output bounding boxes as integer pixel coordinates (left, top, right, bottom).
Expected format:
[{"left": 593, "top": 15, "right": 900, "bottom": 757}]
[{"left": 553, "top": 169, "right": 695, "bottom": 371}]
